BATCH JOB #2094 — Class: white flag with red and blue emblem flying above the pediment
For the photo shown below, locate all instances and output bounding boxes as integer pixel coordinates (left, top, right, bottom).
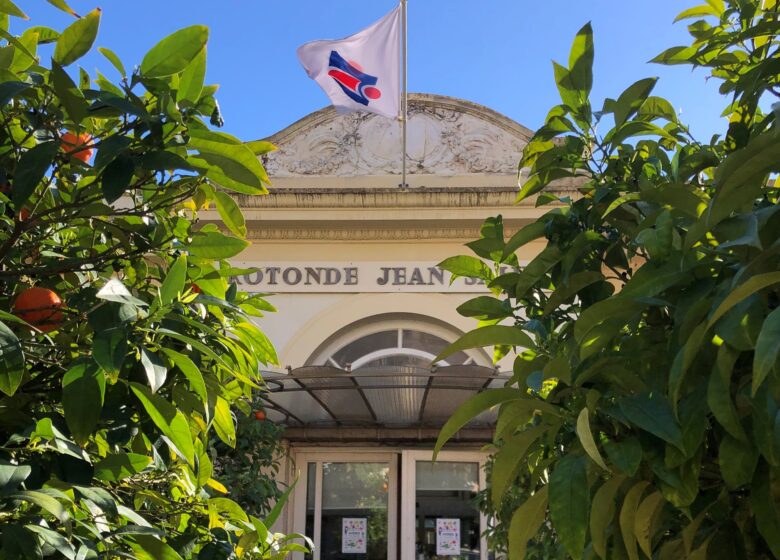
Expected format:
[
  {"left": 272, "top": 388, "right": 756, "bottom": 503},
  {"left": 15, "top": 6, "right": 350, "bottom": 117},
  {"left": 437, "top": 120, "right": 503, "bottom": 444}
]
[{"left": 297, "top": 6, "right": 401, "bottom": 117}]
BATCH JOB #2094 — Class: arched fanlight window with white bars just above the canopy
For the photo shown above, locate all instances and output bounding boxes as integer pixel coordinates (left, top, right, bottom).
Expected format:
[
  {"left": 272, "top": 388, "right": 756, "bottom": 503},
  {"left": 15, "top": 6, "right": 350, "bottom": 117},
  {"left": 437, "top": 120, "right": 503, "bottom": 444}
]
[{"left": 309, "top": 317, "right": 486, "bottom": 371}]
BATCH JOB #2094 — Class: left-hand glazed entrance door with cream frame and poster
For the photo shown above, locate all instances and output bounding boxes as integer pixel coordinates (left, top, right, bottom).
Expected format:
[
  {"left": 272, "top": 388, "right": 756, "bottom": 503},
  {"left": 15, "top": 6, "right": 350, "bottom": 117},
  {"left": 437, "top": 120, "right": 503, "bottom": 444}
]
[{"left": 295, "top": 452, "right": 397, "bottom": 560}]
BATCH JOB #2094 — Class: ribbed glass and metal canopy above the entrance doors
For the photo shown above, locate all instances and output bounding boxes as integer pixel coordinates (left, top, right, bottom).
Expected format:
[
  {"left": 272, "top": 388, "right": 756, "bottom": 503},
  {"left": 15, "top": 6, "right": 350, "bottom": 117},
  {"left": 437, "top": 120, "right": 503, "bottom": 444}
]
[{"left": 263, "top": 365, "right": 509, "bottom": 428}]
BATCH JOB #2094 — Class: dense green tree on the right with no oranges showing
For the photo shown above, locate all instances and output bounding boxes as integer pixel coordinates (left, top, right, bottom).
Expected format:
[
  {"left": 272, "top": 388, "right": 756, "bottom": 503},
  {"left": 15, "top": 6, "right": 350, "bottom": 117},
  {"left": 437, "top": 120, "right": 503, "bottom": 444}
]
[{"left": 438, "top": 0, "right": 780, "bottom": 560}]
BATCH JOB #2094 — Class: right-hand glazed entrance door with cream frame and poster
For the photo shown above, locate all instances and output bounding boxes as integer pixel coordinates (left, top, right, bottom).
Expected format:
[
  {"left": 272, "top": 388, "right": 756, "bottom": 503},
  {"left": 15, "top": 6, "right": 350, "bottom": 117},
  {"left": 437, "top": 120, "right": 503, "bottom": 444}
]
[{"left": 401, "top": 451, "right": 488, "bottom": 560}]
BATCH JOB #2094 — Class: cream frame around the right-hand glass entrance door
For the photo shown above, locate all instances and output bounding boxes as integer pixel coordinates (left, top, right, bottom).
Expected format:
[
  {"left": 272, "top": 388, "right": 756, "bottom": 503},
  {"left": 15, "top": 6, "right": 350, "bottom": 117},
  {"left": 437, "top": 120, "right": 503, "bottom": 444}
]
[{"left": 400, "top": 449, "right": 488, "bottom": 560}]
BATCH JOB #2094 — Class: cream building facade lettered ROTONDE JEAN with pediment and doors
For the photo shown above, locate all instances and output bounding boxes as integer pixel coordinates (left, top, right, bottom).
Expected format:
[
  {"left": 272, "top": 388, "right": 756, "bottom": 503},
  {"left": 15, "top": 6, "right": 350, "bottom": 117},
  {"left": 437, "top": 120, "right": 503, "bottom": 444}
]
[{"left": 212, "top": 94, "right": 566, "bottom": 560}]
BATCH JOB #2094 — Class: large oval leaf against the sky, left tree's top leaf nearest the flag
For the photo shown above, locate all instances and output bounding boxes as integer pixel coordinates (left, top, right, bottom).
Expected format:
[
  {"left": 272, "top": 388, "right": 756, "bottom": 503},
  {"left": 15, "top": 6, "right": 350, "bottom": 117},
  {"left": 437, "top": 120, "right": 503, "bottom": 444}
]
[{"left": 141, "top": 25, "right": 209, "bottom": 78}]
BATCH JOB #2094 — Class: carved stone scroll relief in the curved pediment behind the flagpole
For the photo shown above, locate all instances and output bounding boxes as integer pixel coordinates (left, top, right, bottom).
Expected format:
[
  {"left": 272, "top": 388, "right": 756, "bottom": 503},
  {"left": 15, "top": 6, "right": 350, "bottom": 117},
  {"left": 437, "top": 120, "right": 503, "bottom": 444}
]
[{"left": 264, "top": 96, "right": 527, "bottom": 177}]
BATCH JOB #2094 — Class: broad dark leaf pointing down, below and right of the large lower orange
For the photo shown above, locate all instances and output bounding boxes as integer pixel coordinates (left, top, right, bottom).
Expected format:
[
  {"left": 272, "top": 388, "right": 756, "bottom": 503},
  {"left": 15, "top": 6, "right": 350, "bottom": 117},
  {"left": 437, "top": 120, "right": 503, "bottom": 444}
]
[{"left": 62, "top": 362, "right": 106, "bottom": 445}]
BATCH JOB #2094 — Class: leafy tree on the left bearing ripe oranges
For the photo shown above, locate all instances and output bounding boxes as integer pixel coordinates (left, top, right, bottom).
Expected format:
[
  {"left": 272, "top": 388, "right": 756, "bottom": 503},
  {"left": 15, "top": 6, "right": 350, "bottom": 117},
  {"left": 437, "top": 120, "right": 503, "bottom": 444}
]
[{"left": 0, "top": 1, "right": 310, "bottom": 560}]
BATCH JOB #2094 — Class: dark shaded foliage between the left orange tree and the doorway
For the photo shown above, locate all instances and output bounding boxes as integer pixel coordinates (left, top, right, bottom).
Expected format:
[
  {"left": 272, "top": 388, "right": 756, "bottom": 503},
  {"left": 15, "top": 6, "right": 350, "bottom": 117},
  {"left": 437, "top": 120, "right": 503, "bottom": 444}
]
[{"left": 214, "top": 414, "right": 285, "bottom": 517}]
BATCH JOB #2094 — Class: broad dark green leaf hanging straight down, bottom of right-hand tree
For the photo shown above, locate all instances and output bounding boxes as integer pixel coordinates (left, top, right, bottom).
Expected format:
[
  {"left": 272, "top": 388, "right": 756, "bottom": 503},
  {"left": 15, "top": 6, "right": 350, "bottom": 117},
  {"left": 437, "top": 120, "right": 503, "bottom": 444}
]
[{"left": 550, "top": 455, "right": 590, "bottom": 558}]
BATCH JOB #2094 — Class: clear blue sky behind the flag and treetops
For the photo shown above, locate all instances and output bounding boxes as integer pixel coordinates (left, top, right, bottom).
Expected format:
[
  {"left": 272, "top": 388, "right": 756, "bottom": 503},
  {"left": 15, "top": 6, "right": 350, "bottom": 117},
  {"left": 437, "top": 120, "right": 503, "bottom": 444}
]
[{"left": 18, "top": 0, "right": 726, "bottom": 144}]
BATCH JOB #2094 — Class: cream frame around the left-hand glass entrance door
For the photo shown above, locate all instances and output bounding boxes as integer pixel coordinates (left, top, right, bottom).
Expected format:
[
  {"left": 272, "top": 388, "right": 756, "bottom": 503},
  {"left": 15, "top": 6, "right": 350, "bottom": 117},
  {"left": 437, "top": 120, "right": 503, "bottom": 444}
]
[{"left": 292, "top": 448, "right": 398, "bottom": 560}]
